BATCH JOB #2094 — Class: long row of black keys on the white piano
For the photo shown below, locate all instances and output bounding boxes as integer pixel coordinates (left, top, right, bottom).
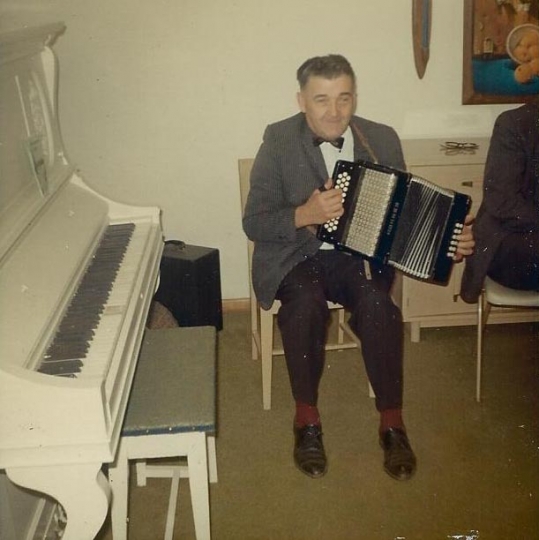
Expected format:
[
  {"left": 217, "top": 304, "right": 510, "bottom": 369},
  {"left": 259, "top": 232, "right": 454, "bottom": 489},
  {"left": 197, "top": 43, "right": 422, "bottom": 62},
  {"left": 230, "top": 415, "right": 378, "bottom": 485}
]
[{"left": 38, "top": 223, "right": 135, "bottom": 377}]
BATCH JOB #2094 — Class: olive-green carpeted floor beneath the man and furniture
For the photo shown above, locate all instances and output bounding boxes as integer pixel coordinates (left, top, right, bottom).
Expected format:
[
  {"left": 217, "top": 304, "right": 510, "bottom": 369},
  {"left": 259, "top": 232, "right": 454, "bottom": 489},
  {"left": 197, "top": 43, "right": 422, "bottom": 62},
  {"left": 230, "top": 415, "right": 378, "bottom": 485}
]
[{"left": 98, "top": 313, "right": 539, "bottom": 540}]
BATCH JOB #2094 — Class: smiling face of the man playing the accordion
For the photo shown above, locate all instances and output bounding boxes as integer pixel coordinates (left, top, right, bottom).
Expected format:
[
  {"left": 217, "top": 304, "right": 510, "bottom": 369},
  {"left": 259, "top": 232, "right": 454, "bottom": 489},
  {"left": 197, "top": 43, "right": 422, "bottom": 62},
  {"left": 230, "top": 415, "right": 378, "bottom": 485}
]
[{"left": 297, "top": 75, "right": 356, "bottom": 141}]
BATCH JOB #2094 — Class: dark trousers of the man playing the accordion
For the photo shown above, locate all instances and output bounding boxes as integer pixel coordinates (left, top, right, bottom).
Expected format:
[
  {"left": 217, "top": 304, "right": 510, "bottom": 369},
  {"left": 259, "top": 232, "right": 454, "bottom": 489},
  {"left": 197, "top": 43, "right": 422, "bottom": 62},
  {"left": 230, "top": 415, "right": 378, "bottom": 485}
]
[{"left": 277, "top": 250, "right": 403, "bottom": 411}]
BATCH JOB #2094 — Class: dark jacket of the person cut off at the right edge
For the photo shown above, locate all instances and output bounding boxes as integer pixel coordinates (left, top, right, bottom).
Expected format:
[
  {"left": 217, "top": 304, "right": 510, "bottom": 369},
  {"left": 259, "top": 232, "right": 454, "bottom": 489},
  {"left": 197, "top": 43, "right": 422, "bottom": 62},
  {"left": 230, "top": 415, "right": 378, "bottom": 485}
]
[{"left": 460, "top": 101, "right": 539, "bottom": 302}]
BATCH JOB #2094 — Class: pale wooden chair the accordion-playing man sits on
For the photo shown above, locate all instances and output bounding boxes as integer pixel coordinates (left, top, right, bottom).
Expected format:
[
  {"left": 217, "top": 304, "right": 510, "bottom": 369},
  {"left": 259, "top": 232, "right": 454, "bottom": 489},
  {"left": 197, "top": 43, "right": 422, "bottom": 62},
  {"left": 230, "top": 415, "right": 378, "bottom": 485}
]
[{"left": 238, "top": 159, "right": 374, "bottom": 409}]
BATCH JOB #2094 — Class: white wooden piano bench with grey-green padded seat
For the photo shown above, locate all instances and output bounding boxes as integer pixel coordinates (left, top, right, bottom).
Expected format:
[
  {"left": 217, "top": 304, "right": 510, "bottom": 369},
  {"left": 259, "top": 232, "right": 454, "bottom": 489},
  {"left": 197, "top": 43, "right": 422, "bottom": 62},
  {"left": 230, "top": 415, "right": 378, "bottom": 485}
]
[{"left": 109, "top": 326, "right": 217, "bottom": 540}]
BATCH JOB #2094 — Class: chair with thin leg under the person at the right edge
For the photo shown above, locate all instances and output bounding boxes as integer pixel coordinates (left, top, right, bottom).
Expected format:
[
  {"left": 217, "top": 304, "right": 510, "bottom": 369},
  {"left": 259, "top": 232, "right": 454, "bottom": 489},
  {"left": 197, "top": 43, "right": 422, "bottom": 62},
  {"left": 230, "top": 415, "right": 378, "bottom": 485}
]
[{"left": 475, "top": 277, "right": 539, "bottom": 402}]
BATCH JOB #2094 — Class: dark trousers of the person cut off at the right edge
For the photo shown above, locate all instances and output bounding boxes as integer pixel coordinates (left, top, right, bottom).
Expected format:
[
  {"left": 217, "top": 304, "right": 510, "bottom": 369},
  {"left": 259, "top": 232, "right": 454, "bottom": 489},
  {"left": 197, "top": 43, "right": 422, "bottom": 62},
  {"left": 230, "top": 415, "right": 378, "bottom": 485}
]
[{"left": 488, "top": 231, "right": 539, "bottom": 291}]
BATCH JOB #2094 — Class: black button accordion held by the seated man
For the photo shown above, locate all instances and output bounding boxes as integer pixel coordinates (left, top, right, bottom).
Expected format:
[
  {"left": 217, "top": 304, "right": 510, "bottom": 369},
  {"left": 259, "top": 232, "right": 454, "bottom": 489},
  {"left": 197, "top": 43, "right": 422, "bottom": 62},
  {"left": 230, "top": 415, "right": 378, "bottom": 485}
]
[{"left": 317, "top": 160, "right": 471, "bottom": 284}]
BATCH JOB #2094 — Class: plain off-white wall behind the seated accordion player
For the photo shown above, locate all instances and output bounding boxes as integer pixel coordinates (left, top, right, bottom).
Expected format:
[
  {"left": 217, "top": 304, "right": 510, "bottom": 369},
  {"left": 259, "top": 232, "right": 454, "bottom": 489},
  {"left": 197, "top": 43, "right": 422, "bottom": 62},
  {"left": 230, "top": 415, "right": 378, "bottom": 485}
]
[{"left": 0, "top": 0, "right": 510, "bottom": 299}]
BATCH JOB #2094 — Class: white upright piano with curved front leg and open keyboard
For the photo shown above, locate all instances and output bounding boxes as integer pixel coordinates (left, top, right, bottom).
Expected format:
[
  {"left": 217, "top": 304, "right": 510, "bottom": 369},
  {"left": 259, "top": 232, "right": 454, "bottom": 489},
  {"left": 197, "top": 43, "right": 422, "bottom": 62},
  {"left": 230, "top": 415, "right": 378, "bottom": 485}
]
[{"left": 0, "top": 23, "right": 163, "bottom": 540}]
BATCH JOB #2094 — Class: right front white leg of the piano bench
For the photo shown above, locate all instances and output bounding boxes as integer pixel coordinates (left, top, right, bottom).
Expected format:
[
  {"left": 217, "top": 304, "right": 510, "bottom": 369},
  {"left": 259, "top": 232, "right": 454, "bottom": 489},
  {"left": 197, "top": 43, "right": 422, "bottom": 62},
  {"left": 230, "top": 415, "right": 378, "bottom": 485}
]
[{"left": 187, "top": 432, "right": 211, "bottom": 540}]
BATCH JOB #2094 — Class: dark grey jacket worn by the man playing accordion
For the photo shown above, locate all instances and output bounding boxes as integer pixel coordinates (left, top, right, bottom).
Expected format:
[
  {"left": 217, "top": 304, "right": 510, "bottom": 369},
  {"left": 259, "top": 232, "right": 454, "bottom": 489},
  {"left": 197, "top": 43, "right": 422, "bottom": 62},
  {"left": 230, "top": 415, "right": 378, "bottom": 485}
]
[{"left": 243, "top": 113, "right": 405, "bottom": 309}]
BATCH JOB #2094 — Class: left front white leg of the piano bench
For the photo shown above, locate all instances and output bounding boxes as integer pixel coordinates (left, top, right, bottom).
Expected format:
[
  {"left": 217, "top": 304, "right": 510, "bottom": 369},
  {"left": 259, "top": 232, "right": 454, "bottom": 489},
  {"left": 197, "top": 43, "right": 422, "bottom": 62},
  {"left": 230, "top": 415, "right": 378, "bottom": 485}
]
[{"left": 109, "top": 439, "right": 129, "bottom": 540}]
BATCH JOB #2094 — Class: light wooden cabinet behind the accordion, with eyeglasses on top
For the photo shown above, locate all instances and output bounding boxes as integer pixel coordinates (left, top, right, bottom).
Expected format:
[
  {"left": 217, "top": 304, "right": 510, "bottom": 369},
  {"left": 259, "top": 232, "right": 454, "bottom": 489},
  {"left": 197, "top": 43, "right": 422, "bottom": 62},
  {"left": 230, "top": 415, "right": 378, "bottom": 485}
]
[{"left": 394, "top": 138, "right": 538, "bottom": 341}]
